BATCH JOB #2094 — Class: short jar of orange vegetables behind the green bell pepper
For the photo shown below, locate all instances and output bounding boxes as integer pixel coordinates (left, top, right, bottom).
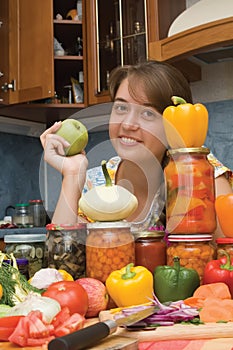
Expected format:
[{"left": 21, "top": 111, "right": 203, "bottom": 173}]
[{"left": 167, "top": 234, "right": 216, "bottom": 283}]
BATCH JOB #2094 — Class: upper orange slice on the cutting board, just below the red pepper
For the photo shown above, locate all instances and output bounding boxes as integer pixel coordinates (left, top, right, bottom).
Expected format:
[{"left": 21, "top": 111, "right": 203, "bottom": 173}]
[{"left": 193, "top": 282, "right": 231, "bottom": 299}]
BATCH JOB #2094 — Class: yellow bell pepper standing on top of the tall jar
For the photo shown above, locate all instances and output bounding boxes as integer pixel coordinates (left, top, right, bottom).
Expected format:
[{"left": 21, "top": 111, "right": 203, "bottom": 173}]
[{"left": 163, "top": 96, "right": 208, "bottom": 148}]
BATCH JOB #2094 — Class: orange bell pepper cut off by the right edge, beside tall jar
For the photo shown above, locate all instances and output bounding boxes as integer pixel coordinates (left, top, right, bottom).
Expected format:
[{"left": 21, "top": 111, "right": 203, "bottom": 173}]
[{"left": 215, "top": 193, "right": 233, "bottom": 237}]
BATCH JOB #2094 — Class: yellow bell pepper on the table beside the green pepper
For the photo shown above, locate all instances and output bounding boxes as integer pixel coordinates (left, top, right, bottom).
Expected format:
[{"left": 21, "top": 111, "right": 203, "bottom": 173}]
[{"left": 106, "top": 263, "right": 153, "bottom": 307}]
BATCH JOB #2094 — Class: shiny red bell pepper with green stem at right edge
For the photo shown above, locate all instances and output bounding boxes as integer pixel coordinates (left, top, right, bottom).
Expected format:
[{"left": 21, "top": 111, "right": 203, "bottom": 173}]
[{"left": 203, "top": 251, "right": 233, "bottom": 298}]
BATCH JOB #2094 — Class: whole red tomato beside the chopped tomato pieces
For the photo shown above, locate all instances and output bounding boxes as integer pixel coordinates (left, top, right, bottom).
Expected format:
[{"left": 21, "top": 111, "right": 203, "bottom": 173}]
[{"left": 42, "top": 281, "right": 88, "bottom": 316}]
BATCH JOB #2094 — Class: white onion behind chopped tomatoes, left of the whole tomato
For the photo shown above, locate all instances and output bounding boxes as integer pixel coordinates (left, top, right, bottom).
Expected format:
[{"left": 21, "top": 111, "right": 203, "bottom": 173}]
[{"left": 7, "top": 293, "right": 61, "bottom": 323}]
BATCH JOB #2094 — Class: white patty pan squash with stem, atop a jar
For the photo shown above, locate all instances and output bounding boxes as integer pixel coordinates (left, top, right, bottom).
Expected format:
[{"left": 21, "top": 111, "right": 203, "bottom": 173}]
[{"left": 79, "top": 161, "right": 138, "bottom": 221}]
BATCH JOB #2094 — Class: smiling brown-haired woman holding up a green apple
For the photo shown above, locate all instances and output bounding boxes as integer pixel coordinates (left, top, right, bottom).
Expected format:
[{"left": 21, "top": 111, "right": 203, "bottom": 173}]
[{"left": 41, "top": 61, "right": 232, "bottom": 239}]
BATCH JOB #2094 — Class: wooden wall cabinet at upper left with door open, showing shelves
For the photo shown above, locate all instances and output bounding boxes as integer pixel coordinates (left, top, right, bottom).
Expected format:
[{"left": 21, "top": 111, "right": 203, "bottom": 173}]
[{"left": 0, "top": 0, "right": 86, "bottom": 110}]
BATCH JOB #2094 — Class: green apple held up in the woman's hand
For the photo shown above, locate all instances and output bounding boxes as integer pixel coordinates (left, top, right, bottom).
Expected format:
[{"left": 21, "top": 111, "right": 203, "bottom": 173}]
[{"left": 56, "top": 119, "right": 88, "bottom": 156}]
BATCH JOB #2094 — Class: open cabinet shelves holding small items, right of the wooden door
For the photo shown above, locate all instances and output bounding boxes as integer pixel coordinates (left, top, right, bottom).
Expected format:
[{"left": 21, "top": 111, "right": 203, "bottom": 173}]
[{"left": 53, "top": 0, "right": 87, "bottom": 108}]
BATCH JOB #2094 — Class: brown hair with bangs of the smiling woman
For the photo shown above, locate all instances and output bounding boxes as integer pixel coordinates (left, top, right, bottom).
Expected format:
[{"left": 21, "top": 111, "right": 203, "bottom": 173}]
[{"left": 109, "top": 61, "right": 192, "bottom": 113}]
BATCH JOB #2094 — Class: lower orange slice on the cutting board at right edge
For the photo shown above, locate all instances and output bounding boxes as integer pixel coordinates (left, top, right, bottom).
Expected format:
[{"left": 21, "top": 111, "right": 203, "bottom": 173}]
[{"left": 199, "top": 298, "right": 233, "bottom": 323}]
